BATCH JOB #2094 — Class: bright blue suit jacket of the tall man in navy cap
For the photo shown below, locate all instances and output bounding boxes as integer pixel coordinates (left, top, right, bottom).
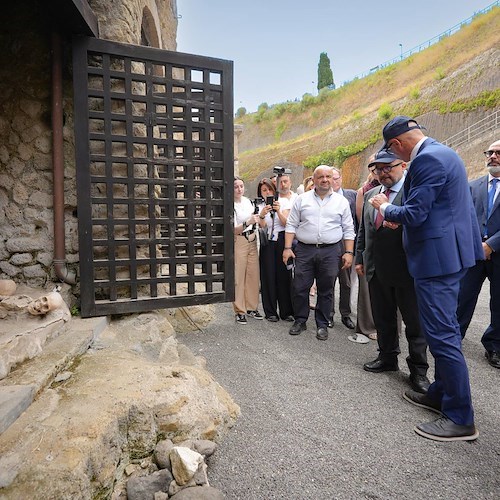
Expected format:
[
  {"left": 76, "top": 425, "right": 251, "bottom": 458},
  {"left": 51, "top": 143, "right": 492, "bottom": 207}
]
[{"left": 385, "top": 138, "right": 484, "bottom": 278}]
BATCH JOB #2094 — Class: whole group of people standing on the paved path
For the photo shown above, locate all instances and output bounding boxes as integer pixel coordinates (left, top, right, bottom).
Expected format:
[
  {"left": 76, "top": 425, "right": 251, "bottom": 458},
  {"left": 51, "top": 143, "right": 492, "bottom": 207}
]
[{"left": 233, "top": 116, "right": 500, "bottom": 441}]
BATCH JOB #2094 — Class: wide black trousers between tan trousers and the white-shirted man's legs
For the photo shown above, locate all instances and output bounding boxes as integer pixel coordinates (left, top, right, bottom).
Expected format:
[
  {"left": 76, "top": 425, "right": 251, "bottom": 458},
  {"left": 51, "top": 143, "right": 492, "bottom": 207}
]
[{"left": 259, "top": 231, "right": 294, "bottom": 319}]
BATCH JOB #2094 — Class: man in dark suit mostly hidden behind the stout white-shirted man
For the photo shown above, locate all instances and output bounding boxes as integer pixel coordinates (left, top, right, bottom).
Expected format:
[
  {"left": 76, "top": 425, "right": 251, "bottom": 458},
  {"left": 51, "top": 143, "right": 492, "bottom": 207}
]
[{"left": 328, "top": 167, "right": 357, "bottom": 330}]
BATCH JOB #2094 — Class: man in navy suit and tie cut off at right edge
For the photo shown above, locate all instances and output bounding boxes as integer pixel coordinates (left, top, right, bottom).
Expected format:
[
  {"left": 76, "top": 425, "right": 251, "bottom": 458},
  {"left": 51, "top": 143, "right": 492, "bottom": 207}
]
[{"left": 457, "top": 141, "right": 500, "bottom": 368}]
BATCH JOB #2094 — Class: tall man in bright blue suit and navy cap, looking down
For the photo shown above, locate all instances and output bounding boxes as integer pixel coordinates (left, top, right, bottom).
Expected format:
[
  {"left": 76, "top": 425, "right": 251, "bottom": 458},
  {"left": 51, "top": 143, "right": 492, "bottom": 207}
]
[{"left": 370, "top": 116, "right": 484, "bottom": 441}]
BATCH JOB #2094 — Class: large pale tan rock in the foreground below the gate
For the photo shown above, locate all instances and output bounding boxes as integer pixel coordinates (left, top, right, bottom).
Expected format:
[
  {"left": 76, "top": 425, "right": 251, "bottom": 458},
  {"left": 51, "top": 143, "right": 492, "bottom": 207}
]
[{"left": 0, "top": 312, "right": 239, "bottom": 499}]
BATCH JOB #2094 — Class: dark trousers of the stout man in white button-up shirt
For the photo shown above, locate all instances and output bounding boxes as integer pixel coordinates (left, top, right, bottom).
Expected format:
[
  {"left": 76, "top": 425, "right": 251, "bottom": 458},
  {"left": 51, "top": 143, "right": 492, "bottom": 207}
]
[{"left": 293, "top": 242, "right": 341, "bottom": 328}]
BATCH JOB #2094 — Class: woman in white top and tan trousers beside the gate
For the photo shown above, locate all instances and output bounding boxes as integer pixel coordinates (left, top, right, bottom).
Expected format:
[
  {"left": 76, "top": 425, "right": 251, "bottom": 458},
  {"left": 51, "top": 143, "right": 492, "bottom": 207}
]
[{"left": 233, "top": 177, "right": 265, "bottom": 325}]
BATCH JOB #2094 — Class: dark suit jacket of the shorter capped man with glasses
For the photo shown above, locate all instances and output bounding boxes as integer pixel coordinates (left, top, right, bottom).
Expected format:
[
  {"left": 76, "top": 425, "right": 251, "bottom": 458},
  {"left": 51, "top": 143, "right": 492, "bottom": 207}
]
[{"left": 356, "top": 186, "right": 413, "bottom": 287}]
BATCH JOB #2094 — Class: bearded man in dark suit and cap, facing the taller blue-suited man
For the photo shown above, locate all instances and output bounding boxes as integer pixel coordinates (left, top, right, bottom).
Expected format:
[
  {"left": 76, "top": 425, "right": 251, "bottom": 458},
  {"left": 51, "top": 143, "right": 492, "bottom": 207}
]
[{"left": 355, "top": 150, "right": 430, "bottom": 394}]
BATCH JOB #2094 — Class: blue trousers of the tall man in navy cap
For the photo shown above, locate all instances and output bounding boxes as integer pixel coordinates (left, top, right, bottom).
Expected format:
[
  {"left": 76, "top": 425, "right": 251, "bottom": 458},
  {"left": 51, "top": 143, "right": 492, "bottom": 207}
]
[{"left": 415, "top": 270, "right": 474, "bottom": 425}]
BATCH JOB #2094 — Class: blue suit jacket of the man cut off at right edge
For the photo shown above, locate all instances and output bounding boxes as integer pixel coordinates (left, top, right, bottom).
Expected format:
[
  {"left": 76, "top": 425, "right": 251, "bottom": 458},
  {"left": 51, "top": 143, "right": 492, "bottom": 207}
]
[{"left": 470, "top": 175, "right": 500, "bottom": 262}]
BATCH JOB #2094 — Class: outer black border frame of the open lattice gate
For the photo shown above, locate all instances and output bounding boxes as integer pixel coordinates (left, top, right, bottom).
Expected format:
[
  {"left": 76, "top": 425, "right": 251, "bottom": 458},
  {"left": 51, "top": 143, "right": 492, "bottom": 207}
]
[{"left": 73, "top": 36, "right": 234, "bottom": 317}]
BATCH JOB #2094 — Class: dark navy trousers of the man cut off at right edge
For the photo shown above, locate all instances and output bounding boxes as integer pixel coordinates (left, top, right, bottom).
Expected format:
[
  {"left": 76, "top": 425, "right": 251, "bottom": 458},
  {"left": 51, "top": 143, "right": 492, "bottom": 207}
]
[{"left": 457, "top": 258, "right": 500, "bottom": 352}]
